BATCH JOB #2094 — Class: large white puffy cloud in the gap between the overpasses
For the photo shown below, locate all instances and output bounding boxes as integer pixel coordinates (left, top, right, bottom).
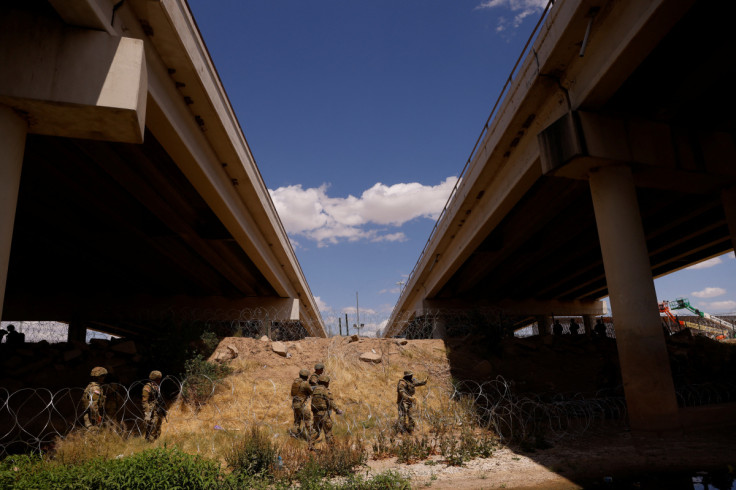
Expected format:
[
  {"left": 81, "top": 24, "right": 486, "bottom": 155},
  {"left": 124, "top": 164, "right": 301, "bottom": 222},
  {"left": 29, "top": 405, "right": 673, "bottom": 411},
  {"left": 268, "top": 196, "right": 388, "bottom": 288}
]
[{"left": 269, "top": 177, "right": 457, "bottom": 247}]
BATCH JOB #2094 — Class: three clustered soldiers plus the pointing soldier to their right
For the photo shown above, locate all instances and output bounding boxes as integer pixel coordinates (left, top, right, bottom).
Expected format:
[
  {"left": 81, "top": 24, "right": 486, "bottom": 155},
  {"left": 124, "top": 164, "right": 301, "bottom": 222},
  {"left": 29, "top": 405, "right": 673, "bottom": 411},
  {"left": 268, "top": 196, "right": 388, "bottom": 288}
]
[{"left": 289, "top": 363, "right": 427, "bottom": 449}]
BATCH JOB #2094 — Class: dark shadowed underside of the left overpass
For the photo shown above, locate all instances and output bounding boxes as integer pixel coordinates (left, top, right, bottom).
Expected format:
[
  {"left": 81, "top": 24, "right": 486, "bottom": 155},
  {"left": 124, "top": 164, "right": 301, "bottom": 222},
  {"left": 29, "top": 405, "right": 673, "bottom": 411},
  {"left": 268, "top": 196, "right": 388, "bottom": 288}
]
[{"left": 3, "top": 132, "right": 290, "bottom": 336}]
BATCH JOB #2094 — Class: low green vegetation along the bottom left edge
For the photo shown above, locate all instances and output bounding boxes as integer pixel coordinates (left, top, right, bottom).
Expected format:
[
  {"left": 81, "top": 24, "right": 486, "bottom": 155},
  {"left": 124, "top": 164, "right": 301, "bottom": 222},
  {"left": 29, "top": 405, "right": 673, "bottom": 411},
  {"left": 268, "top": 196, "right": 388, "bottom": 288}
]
[{"left": 0, "top": 444, "right": 410, "bottom": 490}]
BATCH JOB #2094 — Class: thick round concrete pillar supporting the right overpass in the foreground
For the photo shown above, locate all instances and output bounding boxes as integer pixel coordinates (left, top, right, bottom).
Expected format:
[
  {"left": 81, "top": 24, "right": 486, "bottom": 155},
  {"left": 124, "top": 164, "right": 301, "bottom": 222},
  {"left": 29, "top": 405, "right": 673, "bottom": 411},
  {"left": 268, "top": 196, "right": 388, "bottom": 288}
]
[{"left": 590, "top": 165, "right": 680, "bottom": 431}]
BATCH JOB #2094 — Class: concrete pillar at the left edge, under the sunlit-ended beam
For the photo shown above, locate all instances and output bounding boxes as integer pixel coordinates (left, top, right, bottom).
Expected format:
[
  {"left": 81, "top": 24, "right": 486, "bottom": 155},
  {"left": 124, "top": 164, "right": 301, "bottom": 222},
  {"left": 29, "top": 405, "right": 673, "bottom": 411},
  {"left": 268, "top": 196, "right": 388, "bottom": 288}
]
[{"left": 0, "top": 105, "right": 28, "bottom": 318}]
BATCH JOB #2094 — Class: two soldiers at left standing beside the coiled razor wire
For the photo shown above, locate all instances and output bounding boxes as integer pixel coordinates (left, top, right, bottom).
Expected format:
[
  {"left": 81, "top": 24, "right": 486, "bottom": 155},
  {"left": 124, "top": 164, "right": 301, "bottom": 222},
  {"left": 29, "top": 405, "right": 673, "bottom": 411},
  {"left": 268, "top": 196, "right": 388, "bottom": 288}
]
[{"left": 81, "top": 366, "right": 166, "bottom": 441}]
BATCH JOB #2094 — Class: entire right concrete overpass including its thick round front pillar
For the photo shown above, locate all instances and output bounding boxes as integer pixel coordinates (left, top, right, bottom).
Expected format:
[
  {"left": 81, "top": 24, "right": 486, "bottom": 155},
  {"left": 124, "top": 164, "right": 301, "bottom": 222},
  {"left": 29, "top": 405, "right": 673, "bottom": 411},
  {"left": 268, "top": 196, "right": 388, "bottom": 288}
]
[{"left": 385, "top": 0, "right": 736, "bottom": 429}]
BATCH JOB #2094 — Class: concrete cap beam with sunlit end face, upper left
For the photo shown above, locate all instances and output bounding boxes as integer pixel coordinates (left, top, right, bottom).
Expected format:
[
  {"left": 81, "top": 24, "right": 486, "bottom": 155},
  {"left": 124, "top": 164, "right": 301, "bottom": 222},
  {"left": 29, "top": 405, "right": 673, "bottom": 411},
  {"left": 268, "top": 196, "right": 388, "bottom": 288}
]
[{"left": 0, "top": 12, "right": 147, "bottom": 143}]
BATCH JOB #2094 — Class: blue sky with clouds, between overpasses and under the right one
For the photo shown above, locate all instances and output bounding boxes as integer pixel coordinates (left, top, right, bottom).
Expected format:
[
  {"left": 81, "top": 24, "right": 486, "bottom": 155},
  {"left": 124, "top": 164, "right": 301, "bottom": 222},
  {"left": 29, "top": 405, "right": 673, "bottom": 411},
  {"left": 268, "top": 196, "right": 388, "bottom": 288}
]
[{"left": 189, "top": 0, "right": 736, "bottom": 331}]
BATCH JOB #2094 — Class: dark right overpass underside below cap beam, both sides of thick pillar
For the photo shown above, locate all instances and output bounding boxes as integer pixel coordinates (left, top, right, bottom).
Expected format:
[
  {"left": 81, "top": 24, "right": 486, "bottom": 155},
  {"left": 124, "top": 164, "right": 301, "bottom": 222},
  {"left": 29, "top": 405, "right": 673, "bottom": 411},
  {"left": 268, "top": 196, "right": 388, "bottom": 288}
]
[{"left": 435, "top": 177, "right": 733, "bottom": 303}]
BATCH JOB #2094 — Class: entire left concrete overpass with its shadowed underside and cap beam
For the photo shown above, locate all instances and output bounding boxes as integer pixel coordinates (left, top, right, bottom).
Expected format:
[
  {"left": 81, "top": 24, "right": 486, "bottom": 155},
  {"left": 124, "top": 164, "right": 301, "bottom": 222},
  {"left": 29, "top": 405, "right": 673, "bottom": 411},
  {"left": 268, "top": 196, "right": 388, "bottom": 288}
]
[{"left": 0, "top": 0, "right": 325, "bottom": 338}]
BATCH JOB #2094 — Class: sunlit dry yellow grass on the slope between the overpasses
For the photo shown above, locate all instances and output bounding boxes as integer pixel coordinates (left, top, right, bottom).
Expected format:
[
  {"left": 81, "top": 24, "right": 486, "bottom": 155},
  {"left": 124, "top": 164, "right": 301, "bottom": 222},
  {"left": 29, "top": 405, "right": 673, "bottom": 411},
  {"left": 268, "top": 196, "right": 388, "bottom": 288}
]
[{"left": 51, "top": 338, "right": 472, "bottom": 468}]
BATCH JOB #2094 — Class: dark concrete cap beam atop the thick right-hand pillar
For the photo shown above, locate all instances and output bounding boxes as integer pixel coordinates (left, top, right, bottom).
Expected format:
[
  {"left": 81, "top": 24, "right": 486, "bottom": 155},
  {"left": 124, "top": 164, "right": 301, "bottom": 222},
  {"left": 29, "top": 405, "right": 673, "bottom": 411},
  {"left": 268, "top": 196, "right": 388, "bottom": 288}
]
[{"left": 537, "top": 111, "right": 736, "bottom": 193}]
